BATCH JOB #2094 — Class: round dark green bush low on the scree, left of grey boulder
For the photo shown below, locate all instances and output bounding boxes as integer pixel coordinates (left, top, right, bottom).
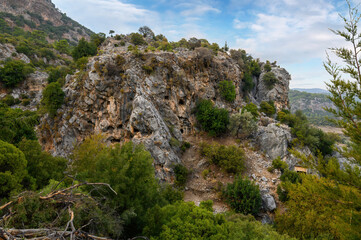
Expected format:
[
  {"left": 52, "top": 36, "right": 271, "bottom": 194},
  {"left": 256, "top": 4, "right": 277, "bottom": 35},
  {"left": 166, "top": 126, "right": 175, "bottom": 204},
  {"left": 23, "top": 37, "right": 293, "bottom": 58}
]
[{"left": 223, "top": 177, "right": 262, "bottom": 215}]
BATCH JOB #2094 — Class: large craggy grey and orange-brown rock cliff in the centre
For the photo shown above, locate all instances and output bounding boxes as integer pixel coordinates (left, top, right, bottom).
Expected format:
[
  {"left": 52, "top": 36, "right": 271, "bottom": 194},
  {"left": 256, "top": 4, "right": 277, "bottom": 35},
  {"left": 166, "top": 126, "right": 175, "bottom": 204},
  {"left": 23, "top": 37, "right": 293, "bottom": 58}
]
[{"left": 38, "top": 39, "right": 290, "bottom": 179}]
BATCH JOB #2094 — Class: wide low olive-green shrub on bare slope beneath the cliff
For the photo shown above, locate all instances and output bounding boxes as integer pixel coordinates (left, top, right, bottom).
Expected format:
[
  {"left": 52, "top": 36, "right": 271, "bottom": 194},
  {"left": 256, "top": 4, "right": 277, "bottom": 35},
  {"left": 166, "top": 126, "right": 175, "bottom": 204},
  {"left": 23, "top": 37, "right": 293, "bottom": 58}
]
[{"left": 200, "top": 143, "right": 245, "bottom": 173}]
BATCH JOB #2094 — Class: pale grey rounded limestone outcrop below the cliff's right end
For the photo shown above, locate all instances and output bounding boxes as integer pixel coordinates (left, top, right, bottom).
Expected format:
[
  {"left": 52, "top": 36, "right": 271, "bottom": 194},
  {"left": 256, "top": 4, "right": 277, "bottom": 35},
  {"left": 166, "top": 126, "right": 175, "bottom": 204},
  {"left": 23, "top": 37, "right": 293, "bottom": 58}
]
[{"left": 256, "top": 123, "right": 291, "bottom": 159}]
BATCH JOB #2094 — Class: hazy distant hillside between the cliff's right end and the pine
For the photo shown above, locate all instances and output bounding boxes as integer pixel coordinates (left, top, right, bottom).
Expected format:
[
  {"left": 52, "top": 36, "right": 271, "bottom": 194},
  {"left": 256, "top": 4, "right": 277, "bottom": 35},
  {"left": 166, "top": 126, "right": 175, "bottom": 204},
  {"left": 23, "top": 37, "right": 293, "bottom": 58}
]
[{"left": 288, "top": 88, "right": 334, "bottom": 125}]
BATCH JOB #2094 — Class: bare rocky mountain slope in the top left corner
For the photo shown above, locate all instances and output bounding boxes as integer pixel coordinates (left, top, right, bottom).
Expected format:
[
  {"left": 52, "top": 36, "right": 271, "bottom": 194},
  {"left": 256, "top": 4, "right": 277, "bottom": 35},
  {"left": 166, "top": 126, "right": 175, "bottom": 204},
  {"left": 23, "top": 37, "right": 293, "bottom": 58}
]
[{"left": 0, "top": 0, "right": 93, "bottom": 44}]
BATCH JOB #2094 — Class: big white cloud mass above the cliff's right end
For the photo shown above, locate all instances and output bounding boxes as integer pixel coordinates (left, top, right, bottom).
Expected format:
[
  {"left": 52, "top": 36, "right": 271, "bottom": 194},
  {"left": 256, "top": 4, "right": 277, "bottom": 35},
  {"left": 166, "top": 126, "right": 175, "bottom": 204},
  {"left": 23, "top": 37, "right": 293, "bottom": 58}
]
[{"left": 234, "top": 0, "right": 345, "bottom": 86}]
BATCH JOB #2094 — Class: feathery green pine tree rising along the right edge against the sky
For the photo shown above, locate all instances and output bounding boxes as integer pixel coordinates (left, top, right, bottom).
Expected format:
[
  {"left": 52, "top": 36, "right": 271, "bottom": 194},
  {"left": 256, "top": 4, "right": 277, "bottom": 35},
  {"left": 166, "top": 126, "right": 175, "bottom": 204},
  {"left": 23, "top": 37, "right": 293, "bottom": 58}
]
[{"left": 324, "top": 0, "right": 361, "bottom": 166}]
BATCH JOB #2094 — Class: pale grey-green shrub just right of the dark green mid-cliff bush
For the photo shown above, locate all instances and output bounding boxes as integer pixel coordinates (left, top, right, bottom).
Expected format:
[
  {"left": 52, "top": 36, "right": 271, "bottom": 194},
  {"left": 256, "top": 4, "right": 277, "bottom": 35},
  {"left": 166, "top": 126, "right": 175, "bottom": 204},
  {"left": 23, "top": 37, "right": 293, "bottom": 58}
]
[{"left": 228, "top": 111, "right": 258, "bottom": 138}]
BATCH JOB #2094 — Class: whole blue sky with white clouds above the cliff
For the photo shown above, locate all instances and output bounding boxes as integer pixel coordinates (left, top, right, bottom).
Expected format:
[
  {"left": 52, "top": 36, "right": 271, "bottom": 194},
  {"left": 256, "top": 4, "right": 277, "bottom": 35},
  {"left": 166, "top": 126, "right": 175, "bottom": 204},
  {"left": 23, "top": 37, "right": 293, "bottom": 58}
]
[{"left": 52, "top": 0, "right": 360, "bottom": 89}]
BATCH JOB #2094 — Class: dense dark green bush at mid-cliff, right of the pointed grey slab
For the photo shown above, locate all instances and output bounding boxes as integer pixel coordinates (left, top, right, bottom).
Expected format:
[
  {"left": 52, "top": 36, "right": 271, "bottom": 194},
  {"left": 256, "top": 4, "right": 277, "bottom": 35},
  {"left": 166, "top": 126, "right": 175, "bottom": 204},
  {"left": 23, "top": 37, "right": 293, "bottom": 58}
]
[{"left": 196, "top": 100, "right": 229, "bottom": 136}]
